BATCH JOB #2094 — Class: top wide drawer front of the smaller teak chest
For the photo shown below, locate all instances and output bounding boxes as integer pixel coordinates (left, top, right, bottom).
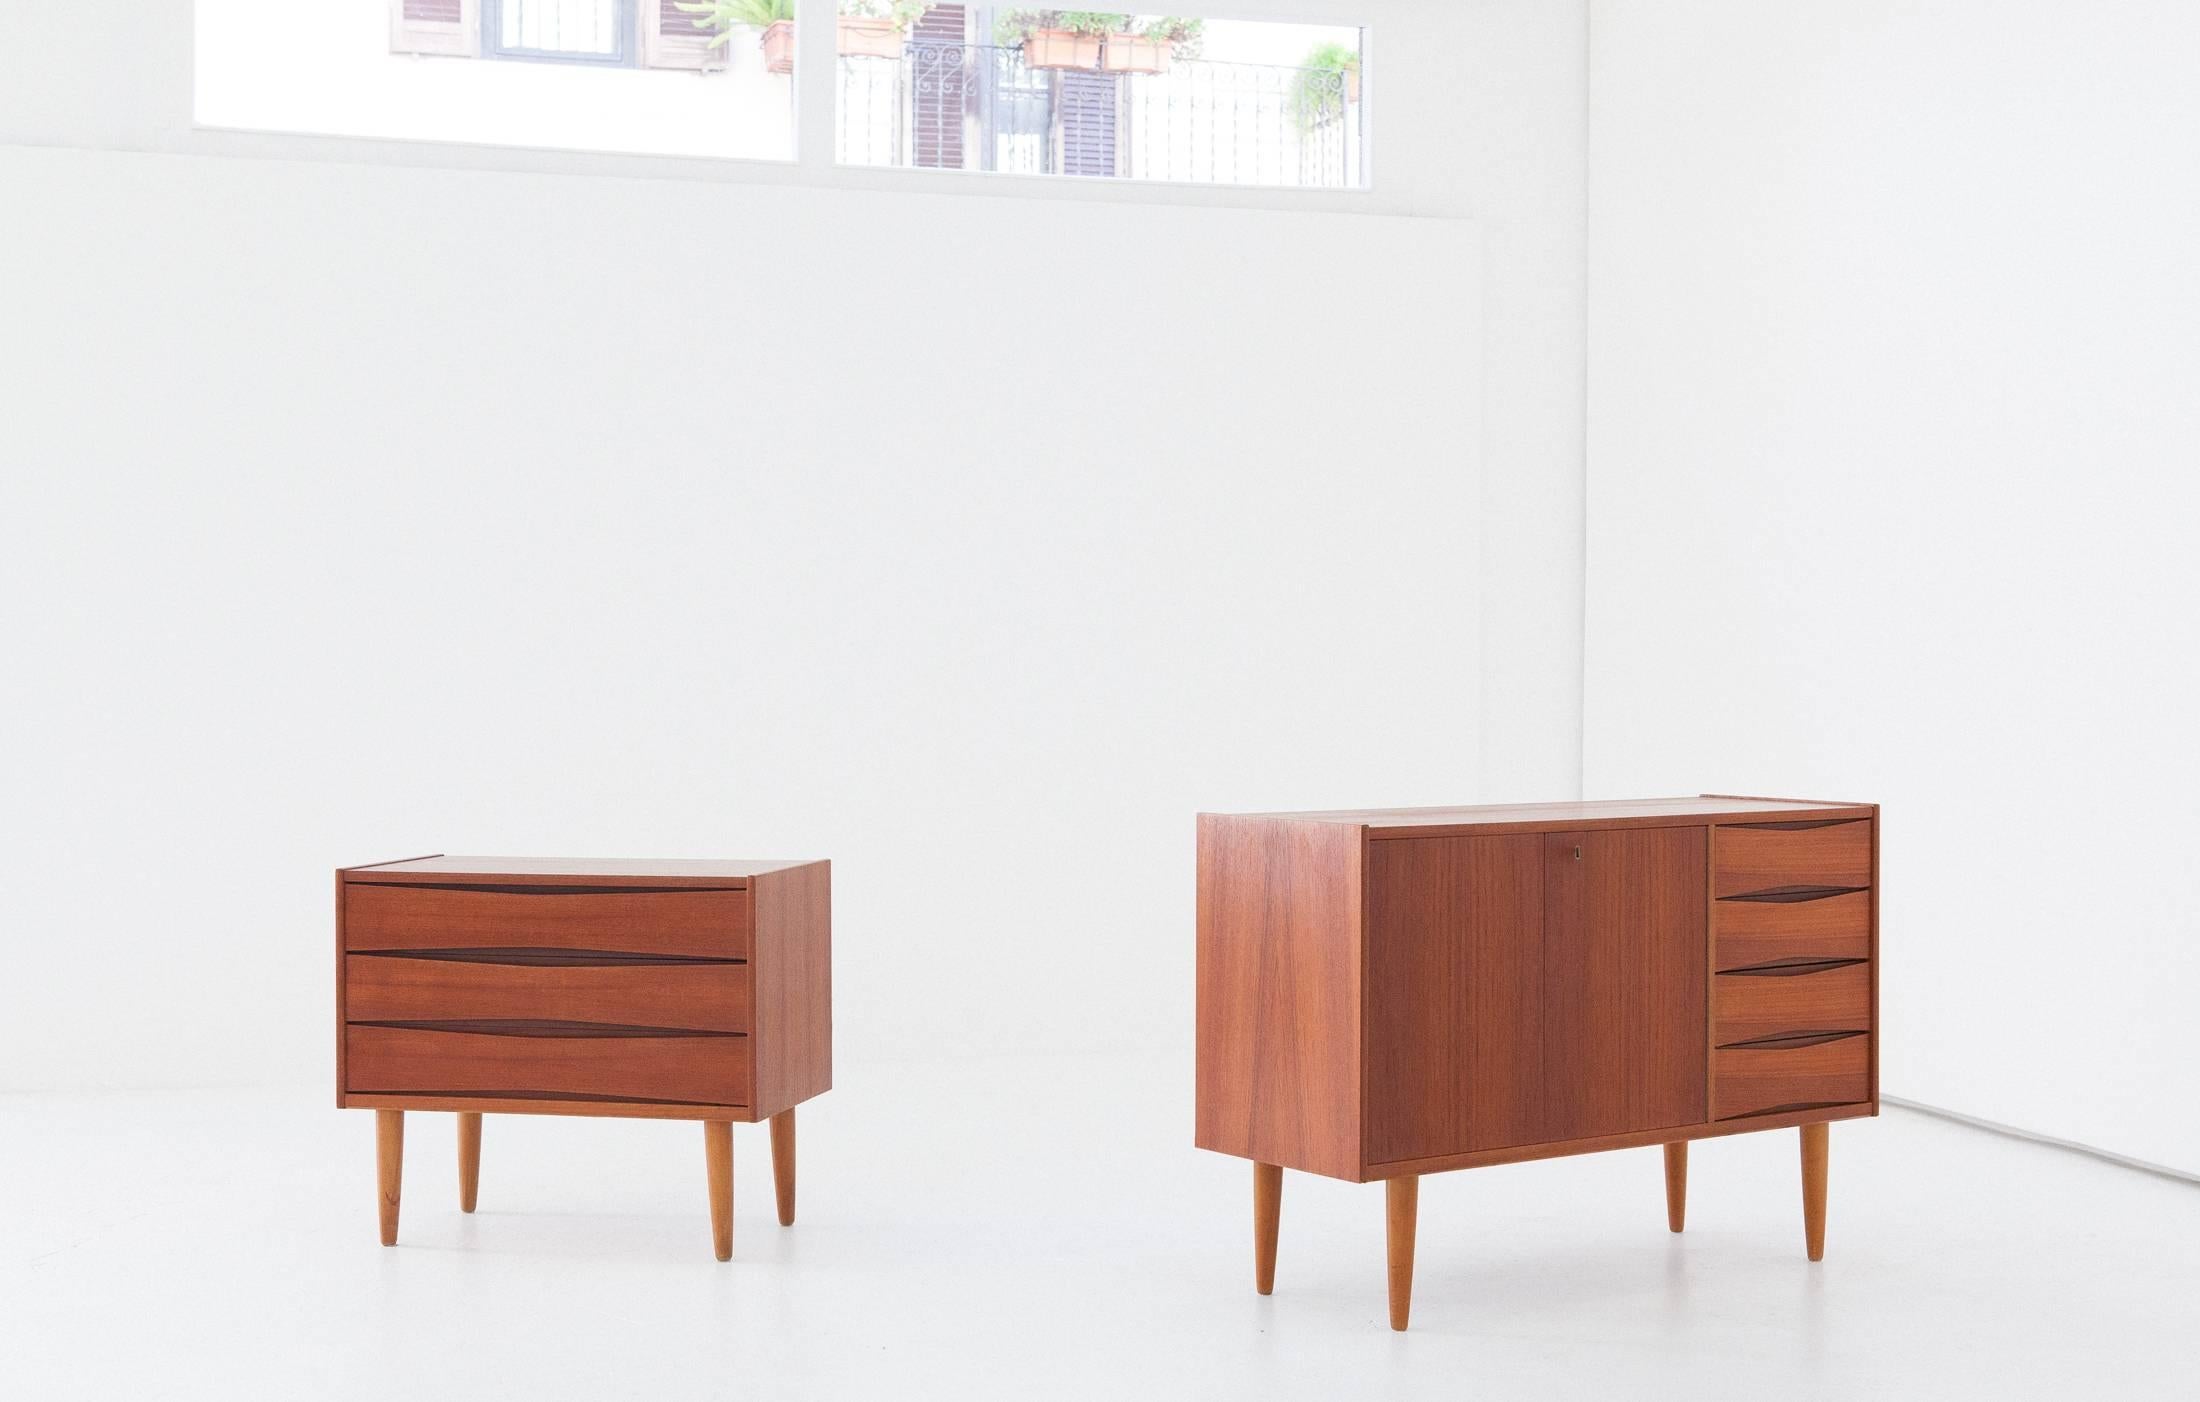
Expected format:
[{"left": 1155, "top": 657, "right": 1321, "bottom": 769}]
[{"left": 343, "top": 880, "right": 748, "bottom": 960}]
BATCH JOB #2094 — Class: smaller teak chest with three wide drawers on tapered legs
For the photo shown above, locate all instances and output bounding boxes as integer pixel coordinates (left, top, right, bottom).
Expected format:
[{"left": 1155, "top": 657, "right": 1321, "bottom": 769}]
[{"left": 337, "top": 856, "right": 832, "bottom": 1261}]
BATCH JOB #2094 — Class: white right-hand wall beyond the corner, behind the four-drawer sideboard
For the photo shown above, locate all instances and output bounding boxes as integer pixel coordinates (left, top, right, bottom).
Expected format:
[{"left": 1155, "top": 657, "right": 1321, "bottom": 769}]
[{"left": 1586, "top": 0, "right": 2200, "bottom": 1171}]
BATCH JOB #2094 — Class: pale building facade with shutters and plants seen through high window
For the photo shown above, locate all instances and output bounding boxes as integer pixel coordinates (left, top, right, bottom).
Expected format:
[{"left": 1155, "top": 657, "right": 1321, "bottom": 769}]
[{"left": 194, "top": 0, "right": 1368, "bottom": 177}]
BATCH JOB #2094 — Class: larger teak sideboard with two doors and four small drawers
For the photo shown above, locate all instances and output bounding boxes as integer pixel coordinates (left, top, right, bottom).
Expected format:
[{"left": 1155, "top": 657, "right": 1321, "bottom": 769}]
[{"left": 1195, "top": 797, "right": 1879, "bottom": 1329}]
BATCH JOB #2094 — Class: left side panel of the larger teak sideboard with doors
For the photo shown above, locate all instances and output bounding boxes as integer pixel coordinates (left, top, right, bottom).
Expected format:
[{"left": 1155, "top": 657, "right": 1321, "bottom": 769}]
[{"left": 1192, "top": 817, "right": 1362, "bottom": 1180}]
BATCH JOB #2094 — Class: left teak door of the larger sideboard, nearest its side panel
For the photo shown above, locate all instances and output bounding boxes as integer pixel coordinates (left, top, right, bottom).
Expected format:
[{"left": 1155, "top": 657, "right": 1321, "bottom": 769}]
[{"left": 1366, "top": 836, "right": 1542, "bottom": 1160}]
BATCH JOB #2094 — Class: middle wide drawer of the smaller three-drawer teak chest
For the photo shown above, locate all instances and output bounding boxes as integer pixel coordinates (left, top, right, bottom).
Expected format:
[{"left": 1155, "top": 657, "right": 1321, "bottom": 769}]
[{"left": 343, "top": 955, "right": 748, "bottom": 1032}]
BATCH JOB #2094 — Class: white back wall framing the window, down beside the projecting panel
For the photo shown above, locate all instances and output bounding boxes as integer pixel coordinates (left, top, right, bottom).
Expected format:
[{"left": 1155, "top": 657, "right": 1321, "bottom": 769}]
[{"left": 0, "top": 0, "right": 1588, "bottom": 799}]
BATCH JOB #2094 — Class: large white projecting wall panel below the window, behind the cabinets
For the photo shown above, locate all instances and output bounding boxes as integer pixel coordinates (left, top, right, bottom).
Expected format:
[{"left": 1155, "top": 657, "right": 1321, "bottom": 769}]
[{"left": 0, "top": 136, "right": 1478, "bottom": 1085}]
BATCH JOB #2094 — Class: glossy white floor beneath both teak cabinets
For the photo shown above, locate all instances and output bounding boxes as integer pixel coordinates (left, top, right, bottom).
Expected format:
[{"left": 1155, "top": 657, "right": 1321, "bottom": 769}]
[{"left": 0, "top": 1056, "right": 2200, "bottom": 1402}]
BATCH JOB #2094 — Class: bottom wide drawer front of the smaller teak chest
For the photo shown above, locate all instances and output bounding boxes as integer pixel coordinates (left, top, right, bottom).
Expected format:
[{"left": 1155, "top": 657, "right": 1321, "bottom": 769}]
[{"left": 345, "top": 1023, "right": 750, "bottom": 1105}]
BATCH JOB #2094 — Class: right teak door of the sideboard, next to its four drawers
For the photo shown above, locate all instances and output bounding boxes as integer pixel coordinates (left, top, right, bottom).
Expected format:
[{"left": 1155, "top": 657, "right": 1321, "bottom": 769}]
[{"left": 1542, "top": 828, "right": 1709, "bottom": 1140}]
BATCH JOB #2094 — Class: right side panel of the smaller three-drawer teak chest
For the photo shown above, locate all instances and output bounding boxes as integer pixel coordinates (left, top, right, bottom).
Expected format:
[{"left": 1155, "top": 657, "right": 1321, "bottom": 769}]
[{"left": 748, "top": 861, "right": 832, "bottom": 1120}]
